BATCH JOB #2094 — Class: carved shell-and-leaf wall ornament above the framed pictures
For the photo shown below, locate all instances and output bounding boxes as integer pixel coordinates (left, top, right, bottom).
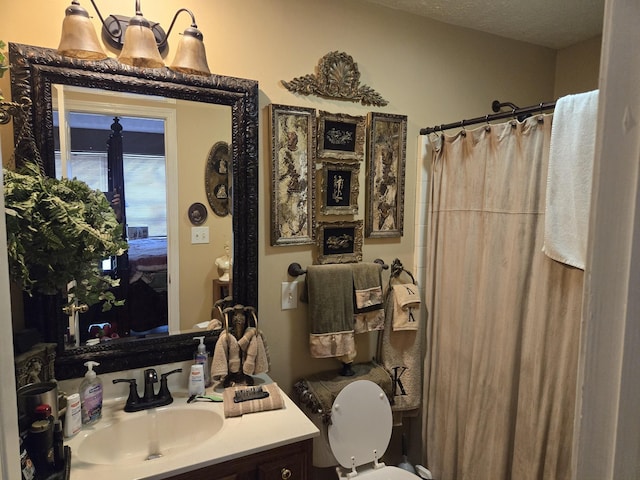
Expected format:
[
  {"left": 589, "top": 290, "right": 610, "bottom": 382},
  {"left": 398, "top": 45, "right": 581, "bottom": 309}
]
[{"left": 282, "top": 51, "right": 389, "bottom": 107}]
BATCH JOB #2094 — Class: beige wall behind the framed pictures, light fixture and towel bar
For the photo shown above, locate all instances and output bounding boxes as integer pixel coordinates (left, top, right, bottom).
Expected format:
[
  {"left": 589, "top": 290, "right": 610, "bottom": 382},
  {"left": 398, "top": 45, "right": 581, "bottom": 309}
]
[{"left": 0, "top": 0, "right": 600, "bottom": 391}]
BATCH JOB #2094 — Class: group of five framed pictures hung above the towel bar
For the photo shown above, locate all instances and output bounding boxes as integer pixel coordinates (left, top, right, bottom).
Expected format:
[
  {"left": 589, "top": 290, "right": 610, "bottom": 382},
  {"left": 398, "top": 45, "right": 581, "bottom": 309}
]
[{"left": 269, "top": 104, "right": 407, "bottom": 264}]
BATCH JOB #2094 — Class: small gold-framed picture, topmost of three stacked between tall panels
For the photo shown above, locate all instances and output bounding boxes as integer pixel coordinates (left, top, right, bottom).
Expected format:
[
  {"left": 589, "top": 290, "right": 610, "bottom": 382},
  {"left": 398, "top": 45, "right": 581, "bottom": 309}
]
[{"left": 318, "top": 111, "right": 366, "bottom": 161}]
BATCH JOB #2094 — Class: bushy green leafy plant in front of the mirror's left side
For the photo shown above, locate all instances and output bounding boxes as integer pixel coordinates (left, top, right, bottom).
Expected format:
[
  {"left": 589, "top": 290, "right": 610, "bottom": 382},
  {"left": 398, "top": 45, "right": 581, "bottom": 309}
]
[{"left": 3, "top": 163, "right": 127, "bottom": 310}]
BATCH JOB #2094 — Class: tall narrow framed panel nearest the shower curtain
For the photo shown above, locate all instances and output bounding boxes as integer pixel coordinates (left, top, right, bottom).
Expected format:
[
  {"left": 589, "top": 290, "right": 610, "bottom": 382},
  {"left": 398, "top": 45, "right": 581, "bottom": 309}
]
[{"left": 365, "top": 112, "right": 407, "bottom": 238}]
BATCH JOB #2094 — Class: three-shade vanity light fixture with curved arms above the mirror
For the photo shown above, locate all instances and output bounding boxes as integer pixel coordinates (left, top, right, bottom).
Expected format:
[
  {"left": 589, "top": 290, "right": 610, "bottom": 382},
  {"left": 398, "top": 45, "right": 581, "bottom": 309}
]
[{"left": 58, "top": 0, "right": 211, "bottom": 75}]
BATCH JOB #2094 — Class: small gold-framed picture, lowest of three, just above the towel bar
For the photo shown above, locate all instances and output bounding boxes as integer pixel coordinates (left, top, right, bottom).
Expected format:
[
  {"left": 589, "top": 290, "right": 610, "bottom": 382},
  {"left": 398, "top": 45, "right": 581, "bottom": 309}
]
[{"left": 316, "top": 220, "right": 362, "bottom": 265}]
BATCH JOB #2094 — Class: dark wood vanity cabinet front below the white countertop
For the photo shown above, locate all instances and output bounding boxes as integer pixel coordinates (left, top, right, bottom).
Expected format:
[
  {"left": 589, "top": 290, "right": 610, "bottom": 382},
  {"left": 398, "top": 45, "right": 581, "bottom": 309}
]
[{"left": 169, "top": 439, "right": 313, "bottom": 480}]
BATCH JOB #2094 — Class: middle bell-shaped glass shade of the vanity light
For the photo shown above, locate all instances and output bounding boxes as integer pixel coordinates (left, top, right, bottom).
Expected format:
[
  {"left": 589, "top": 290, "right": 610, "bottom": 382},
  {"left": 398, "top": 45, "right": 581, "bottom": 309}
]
[{"left": 118, "top": 15, "right": 164, "bottom": 68}]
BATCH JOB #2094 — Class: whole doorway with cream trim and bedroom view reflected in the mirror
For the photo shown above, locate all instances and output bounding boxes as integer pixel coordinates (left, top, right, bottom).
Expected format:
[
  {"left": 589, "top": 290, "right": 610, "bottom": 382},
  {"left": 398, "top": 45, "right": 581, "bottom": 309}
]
[{"left": 52, "top": 85, "right": 180, "bottom": 348}]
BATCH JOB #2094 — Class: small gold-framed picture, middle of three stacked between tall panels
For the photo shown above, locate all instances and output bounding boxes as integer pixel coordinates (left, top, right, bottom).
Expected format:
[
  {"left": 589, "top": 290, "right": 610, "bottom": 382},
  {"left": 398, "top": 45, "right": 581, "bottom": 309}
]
[{"left": 320, "top": 161, "right": 360, "bottom": 215}]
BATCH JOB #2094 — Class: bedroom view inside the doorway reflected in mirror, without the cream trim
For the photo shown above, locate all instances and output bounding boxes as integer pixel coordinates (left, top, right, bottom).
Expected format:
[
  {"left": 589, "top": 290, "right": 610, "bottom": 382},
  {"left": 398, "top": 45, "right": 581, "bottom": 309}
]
[{"left": 54, "top": 109, "right": 169, "bottom": 347}]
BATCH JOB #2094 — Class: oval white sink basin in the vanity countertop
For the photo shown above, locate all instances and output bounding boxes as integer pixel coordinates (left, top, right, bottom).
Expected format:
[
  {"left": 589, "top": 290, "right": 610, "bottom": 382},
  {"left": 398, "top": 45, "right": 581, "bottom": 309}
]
[{"left": 73, "top": 406, "right": 224, "bottom": 465}]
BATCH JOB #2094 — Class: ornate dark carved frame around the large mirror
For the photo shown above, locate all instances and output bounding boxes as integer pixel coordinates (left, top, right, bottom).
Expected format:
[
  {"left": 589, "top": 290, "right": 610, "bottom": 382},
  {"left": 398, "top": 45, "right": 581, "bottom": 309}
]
[{"left": 9, "top": 43, "right": 259, "bottom": 380}]
